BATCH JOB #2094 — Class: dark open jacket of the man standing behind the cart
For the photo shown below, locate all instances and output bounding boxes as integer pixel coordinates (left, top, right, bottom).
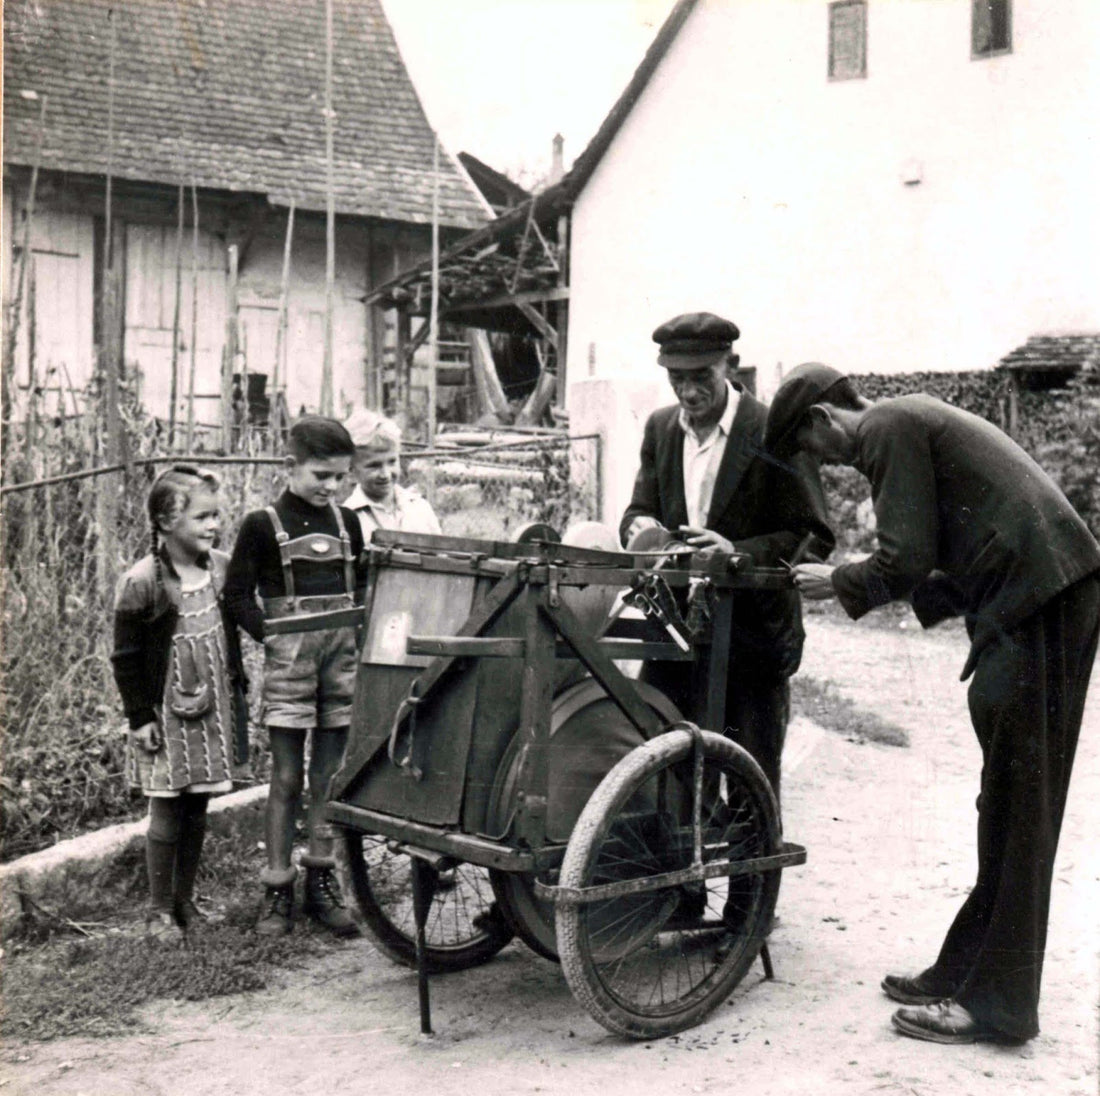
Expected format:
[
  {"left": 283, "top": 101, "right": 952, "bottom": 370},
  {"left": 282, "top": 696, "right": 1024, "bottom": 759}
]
[{"left": 619, "top": 391, "right": 834, "bottom": 677}]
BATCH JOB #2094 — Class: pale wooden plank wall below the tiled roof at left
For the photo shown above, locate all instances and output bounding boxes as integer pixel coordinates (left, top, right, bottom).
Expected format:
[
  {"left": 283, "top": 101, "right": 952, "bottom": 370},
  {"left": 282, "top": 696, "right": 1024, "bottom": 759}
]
[{"left": 3, "top": 171, "right": 430, "bottom": 426}]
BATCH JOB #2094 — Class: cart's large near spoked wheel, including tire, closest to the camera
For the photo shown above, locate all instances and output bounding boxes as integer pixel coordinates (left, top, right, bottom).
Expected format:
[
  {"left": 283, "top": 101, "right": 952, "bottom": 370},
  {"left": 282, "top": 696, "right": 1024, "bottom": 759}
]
[{"left": 556, "top": 730, "right": 781, "bottom": 1039}]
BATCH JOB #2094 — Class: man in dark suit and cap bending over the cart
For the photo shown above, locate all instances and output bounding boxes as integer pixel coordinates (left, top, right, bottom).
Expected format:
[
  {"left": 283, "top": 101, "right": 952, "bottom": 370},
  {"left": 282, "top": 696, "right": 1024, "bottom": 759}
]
[{"left": 767, "top": 362, "right": 1100, "bottom": 1043}]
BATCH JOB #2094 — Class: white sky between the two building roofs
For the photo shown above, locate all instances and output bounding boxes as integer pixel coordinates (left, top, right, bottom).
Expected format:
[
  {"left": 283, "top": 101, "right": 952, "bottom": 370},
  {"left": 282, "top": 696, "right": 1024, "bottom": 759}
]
[{"left": 382, "top": 0, "right": 673, "bottom": 183}]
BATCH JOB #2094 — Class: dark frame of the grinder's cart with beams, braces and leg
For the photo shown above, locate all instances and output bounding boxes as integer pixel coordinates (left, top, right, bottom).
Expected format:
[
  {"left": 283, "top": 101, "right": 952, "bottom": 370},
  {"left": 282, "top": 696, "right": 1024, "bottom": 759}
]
[{"left": 319, "top": 531, "right": 806, "bottom": 1031}]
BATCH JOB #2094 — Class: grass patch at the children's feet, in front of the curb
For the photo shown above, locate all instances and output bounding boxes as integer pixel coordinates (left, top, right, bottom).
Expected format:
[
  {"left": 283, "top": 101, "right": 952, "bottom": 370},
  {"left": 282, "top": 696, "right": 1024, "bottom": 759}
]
[{"left": 0, "top": 834, "right": 352, "bottom": 1041}]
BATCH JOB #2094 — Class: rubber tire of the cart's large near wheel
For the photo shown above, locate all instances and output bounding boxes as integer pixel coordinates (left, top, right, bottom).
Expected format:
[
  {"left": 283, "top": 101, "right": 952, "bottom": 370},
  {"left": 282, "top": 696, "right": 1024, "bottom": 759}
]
[{"left": 556, "top": 731, "right": 782, "bottom": 1039}]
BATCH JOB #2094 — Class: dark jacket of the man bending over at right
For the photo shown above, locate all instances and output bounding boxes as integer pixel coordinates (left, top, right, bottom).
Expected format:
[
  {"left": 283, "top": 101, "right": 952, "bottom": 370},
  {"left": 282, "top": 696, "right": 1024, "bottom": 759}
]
[{"left": 833, "top": 395, "right": 1100, "bottom": 679}]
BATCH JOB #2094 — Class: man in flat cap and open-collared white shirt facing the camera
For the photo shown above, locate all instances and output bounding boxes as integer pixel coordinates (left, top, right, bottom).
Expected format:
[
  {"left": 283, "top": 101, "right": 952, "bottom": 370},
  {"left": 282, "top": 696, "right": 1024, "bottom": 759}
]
[{"left": 619, "top": 313, "right": 834, "bottom": 798}]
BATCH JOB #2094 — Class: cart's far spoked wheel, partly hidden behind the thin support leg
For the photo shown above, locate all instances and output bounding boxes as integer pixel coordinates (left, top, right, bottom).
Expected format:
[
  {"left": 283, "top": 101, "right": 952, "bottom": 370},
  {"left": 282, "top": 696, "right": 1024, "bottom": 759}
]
[{"left": 344, "top": 830, "right": 513, "bottom": 972}]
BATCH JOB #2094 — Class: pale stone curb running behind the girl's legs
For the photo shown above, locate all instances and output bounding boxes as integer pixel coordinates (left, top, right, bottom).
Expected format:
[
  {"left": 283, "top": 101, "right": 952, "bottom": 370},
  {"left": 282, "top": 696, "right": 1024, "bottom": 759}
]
[{"left": 0, "top": 783, "right": 268, "bottom": 939}]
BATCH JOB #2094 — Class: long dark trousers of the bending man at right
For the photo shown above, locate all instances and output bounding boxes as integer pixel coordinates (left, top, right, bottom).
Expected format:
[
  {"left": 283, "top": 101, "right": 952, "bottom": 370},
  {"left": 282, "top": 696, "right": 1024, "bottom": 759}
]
[{"left": 925, "top": 574, "right": 1100, "bottom": 1039}]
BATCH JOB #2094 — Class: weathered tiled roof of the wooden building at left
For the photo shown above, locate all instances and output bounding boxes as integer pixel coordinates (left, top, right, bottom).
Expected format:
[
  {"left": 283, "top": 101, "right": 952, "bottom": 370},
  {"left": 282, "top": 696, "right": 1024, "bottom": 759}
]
[{"left": 3, "top": 0, "right": 488, "bottom": 228}]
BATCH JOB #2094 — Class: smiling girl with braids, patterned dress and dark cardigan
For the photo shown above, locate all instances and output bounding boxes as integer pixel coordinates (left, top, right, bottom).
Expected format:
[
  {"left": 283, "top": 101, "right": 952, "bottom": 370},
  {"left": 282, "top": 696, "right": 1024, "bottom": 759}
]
[{"left": 111, "top": 464, "right": 248, "bottom": 943}]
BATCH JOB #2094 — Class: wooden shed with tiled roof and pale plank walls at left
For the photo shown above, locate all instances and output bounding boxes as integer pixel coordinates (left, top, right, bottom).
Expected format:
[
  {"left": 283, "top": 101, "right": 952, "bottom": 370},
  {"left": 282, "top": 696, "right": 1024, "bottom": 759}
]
[{"left": 2, "top": 0, "right": 491, "bottom": 435}]
